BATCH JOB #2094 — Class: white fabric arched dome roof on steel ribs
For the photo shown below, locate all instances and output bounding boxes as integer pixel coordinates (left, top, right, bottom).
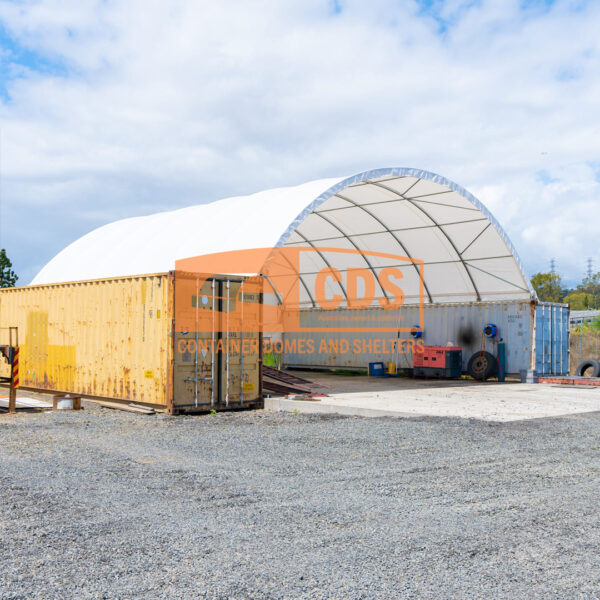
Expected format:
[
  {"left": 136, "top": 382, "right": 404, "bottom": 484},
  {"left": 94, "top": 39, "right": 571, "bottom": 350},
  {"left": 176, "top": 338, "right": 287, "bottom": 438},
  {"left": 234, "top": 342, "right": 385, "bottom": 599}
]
[{"left": 31, "top": 168, "right": 535, "bottom": 305}]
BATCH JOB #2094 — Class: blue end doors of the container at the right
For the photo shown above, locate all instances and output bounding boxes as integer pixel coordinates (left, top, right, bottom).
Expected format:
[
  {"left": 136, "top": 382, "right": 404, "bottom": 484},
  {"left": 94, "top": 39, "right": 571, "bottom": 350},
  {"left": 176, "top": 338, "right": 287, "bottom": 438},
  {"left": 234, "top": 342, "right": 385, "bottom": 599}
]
[{"left": 535, "top": 302, "right": 569, "bottom": 375}]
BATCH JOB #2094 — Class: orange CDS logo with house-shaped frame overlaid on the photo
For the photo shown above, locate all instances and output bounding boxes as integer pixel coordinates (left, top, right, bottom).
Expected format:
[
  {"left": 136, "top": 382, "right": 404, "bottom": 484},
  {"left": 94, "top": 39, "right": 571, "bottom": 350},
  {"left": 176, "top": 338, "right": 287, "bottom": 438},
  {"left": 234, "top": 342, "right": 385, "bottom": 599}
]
[{"left": 175, "top": 246, "right": 424, "bottom": 334}]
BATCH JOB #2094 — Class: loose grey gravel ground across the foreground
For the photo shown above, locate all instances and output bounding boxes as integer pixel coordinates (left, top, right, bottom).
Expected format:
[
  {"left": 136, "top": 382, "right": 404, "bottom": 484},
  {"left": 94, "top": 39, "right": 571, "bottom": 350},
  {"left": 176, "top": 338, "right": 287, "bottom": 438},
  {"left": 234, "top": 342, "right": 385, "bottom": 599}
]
[{"left": 0, "top": 404, "right": 600, "bottom": 600}]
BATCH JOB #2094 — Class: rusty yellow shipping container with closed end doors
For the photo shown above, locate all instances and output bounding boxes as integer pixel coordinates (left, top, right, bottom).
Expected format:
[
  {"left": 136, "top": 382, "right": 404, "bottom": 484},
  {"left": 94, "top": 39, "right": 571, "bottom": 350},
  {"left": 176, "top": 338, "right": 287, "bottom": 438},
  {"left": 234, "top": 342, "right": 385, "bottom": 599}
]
[{"left": 0, "top": 271, "right": 262, "bottom": 413}]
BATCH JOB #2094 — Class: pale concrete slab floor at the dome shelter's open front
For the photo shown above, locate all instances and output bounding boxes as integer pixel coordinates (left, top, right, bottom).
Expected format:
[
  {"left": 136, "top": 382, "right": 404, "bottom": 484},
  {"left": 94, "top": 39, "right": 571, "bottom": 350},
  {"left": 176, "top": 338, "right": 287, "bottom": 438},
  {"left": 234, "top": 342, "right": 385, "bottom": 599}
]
[{"left": 265, "top": 372, "right": 600, "bottom": 421}]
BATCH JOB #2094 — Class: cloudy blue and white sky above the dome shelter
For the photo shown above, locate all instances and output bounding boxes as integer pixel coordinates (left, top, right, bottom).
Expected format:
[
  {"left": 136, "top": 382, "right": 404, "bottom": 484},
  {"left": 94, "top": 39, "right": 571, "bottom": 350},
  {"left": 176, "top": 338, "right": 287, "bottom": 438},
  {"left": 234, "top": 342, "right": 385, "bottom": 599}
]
[{"left": 0, "top": 0, "right": 600, "bottom": 284}]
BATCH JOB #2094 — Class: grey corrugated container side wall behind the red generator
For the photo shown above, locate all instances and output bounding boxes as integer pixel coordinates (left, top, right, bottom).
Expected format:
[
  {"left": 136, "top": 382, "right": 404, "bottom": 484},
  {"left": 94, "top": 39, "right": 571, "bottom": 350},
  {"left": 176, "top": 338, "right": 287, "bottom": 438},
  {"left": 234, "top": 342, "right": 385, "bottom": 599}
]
[{"left": 284, "top": 301, "right": 533, "bottom": 375}]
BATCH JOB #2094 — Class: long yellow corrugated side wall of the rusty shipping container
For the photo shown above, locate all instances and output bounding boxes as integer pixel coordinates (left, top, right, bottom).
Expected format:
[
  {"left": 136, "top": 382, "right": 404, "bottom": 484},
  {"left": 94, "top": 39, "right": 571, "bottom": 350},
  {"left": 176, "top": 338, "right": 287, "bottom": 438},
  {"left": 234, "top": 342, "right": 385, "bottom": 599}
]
[{"left": 0, "top": 274, "right": 172, "bottom": 405}]
